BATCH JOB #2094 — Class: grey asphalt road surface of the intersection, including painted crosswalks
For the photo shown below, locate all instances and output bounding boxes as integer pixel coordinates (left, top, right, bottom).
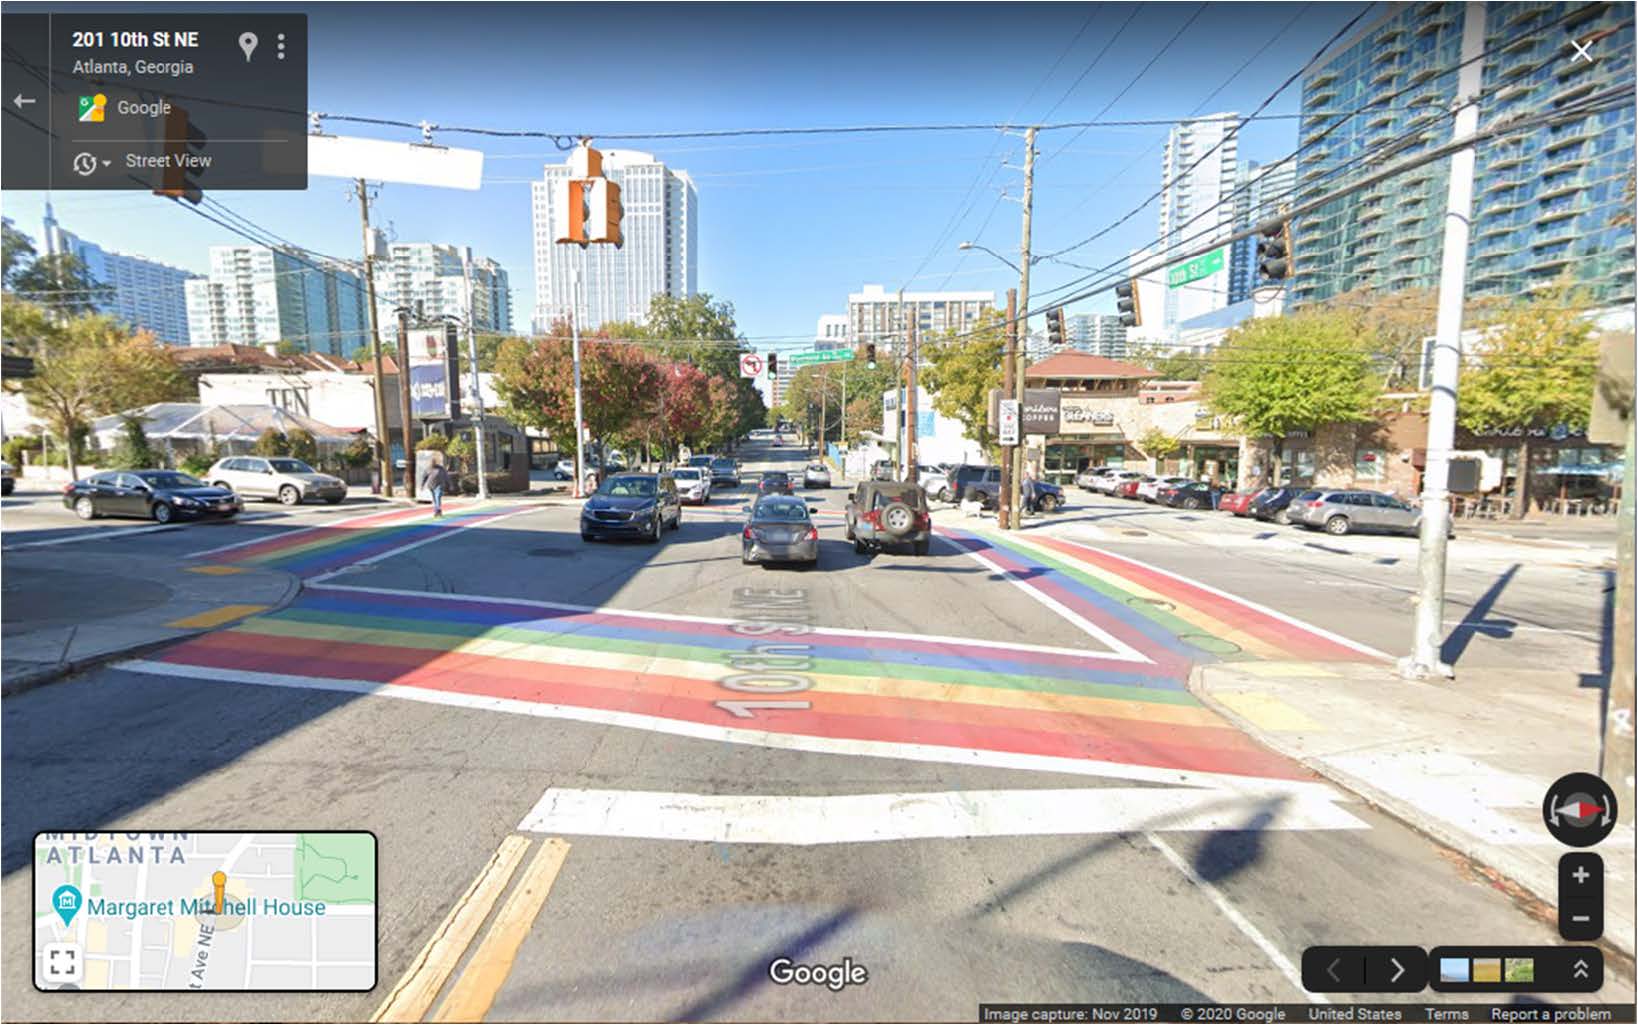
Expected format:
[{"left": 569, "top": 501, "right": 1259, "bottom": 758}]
[{"left": 0, "top": 435, "right": 1633, "bottom": 1022}]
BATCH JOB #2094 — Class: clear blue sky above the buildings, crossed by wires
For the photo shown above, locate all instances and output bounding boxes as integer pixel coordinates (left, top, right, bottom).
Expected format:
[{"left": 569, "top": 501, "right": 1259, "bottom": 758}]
[{"left": 0, "top": 3, "right": 1360, "bottom": 349}]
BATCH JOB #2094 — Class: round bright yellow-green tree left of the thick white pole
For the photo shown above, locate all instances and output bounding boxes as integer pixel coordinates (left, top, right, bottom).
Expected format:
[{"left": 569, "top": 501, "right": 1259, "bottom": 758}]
[{"left": 1202, "top": 309, "right": 1381, "bottom": 480}]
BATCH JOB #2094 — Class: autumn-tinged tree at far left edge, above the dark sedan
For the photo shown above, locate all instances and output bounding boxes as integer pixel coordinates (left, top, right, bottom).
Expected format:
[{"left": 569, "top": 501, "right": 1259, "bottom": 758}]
[{"left": 0, "top": 301, "right": 188, "bottom": 473}]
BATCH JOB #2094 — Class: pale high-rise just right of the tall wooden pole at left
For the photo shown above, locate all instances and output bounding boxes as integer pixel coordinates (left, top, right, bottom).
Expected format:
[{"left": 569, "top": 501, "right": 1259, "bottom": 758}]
[{"left": 375, "top": 239, "right": 511, "bottom": 332}]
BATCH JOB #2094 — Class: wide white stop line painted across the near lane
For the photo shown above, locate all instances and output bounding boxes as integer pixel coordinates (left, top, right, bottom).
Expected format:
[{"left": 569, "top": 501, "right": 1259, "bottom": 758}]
[{"left": 518, "top": 788, "right": 1366, "bottom": 847}]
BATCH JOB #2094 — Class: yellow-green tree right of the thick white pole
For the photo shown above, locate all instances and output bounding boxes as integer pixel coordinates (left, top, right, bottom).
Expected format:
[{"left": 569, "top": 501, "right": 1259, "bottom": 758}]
[{"left": 1456, "top": 282, "right": 1599, "bottom": 519}]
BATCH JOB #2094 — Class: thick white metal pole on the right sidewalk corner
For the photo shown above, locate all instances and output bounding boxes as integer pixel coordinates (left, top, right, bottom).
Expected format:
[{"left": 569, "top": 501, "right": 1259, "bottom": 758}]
[{"left": 1399, "top": 3, "right": 1484, "bottom": 680}]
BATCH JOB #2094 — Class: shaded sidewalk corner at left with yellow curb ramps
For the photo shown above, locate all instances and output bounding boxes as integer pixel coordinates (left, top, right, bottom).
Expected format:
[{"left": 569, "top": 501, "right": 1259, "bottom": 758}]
[{"left": 0, "top": 549, "right": 301, "bottom": 696}]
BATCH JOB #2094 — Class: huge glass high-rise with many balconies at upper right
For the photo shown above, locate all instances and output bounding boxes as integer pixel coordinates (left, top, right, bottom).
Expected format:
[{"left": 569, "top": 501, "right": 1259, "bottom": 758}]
[{"left": 1292, "top": 0, "right": 1635, "bottom": 303}]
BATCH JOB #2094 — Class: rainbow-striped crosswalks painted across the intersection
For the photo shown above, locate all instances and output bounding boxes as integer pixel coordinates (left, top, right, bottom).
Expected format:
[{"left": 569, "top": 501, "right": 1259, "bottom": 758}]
[{"left": 134, "top": 506, "right": 1376, "bottom": 784}]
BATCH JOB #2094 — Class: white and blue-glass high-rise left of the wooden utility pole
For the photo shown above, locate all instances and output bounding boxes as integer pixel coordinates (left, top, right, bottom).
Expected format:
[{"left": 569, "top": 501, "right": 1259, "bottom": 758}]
[{"left": 187, "top": 246, "right": 370, "bottom": 357}]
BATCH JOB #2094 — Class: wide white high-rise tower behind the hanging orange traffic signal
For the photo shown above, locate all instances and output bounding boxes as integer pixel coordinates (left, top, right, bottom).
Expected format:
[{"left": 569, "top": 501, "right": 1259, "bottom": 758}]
[{"left": 532, "top": 149, "right": 699, "bottom": 331}]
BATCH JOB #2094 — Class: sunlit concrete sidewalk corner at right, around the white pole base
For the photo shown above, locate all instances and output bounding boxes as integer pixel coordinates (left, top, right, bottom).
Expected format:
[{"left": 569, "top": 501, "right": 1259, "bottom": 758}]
[{"left": 1189, "top": 662, "right": 1635, "bottom": 956}]
